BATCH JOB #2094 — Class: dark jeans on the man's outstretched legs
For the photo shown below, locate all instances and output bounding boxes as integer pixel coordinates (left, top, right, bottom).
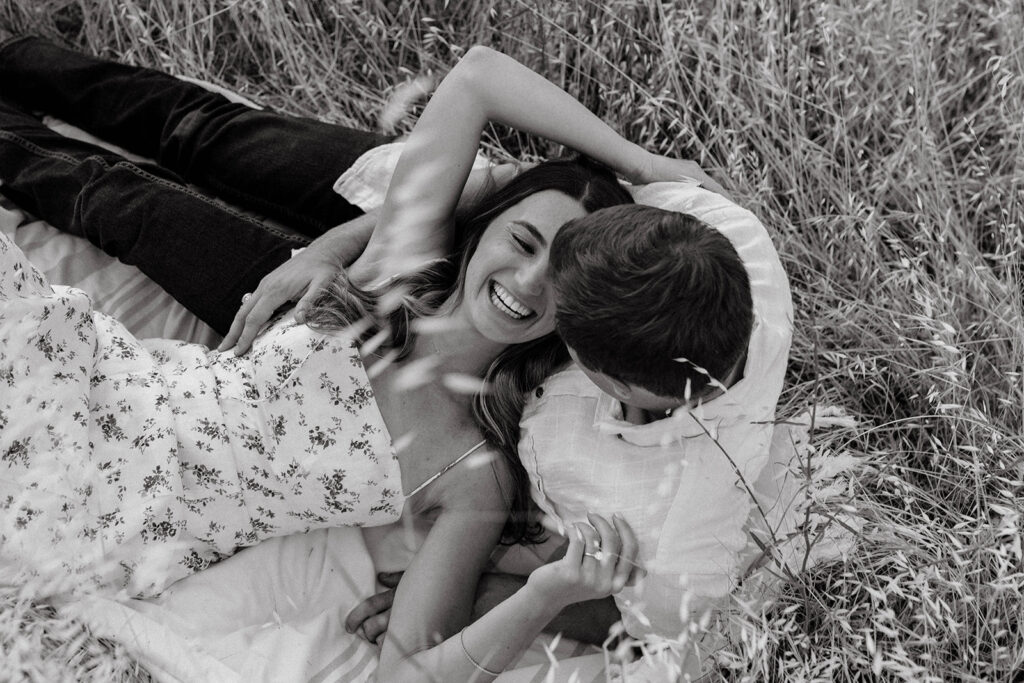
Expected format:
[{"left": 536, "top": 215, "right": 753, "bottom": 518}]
[{"left": 0, "top": 38, "right": 388, "bottom": 334}]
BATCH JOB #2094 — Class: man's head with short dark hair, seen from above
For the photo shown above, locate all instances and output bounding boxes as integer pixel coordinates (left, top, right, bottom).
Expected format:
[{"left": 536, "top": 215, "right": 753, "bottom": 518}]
[{"left": 551, "top": 205, "right": 754, "bottom": 410}]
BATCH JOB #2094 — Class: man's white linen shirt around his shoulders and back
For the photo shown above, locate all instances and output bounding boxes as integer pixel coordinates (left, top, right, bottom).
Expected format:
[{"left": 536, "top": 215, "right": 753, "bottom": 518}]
[{"left": 519, "top": 183, "right": 793, "bottom": 638}]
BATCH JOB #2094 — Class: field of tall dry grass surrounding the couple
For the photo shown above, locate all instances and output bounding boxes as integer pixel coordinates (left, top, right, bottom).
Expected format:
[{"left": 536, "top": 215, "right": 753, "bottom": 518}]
[{"left": 0, "top": 0, "right": 1024, "bottom": 681}]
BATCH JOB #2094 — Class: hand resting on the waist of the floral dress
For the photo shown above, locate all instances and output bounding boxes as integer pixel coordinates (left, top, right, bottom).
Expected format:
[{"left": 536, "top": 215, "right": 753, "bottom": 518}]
[{"left": 217, "top": 245, "right": 344, "bottom": 355}]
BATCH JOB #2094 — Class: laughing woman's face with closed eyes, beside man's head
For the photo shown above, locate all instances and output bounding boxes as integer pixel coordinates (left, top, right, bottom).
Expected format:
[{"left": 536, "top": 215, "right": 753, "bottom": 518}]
[{"left": 460, "top": 189, "right": 587, "bottom": 344}]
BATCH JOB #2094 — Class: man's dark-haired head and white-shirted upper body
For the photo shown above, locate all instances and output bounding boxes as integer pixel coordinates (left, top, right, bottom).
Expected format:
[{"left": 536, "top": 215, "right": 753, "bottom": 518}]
[{"left": 519, "top": 183, "right": 792, "bottom": 672}]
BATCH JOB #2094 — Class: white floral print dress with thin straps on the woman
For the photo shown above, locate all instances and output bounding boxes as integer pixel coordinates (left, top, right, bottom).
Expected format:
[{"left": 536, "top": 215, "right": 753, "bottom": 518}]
[{"left": 0, "top": 234, "right": 403, "bottom": 595}]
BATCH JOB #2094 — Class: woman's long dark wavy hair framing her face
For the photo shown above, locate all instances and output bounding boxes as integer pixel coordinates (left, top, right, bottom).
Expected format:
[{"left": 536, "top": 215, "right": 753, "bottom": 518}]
[{"left": 307, "top": 157, "right": 633, "bottom": 543}]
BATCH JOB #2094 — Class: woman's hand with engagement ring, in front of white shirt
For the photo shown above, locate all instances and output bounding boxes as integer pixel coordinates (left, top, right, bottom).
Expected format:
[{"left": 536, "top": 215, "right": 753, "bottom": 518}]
[{"left": 526, "top": 514, "right": 642, "bottom": 606}]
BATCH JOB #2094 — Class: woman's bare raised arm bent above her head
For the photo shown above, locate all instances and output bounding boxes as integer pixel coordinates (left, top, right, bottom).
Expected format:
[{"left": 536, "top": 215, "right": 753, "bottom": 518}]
[{"left": 353, "top": 46, "right": 714, "bottom": 282}]
